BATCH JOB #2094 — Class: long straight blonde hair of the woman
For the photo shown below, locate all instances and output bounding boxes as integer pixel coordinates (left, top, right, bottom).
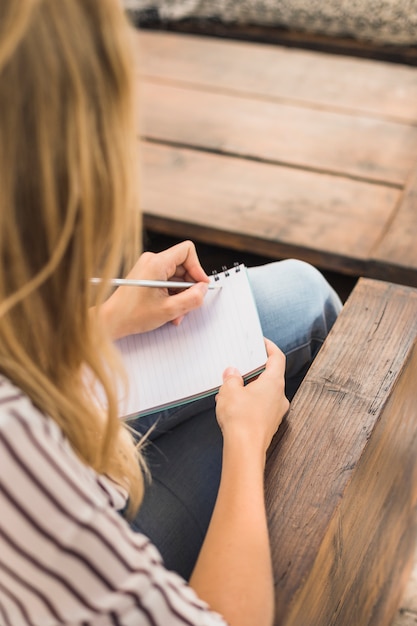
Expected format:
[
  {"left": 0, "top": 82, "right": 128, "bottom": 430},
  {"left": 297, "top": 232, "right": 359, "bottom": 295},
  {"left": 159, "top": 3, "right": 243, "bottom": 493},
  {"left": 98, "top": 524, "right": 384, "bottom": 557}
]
[{"left": 0, "top": 0, "right": 143, "bottom": 511}]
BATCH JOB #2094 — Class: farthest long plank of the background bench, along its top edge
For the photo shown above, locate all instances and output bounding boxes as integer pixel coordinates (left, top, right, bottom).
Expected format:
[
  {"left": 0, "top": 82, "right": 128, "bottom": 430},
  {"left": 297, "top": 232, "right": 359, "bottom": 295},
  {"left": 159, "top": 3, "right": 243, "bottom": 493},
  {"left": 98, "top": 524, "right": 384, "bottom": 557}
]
[{"left": 138, "top": 31, "right": 417, "bottom": 124}]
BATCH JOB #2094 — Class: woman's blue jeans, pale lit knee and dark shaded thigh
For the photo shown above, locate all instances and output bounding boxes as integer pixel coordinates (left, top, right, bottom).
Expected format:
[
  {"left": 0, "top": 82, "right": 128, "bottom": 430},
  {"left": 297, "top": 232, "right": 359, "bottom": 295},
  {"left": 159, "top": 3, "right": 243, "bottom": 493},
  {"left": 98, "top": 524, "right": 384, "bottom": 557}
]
[{"left": 131, "top": 260, "right": 342, "bottom": 578}]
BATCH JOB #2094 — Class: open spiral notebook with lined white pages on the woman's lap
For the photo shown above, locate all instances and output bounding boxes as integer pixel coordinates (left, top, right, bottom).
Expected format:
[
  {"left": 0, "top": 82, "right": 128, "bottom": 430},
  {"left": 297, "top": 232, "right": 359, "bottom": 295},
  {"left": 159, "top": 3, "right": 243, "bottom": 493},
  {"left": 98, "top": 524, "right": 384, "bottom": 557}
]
[{"left": 116, "top": 265, "right": 267, "bottom": 416}]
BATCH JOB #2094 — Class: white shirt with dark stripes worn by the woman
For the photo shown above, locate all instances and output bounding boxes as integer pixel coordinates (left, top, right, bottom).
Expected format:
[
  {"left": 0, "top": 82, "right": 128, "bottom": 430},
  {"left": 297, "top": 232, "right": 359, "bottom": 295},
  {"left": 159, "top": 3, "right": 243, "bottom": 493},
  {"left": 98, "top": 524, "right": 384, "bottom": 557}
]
[{"left": 0, "top": 377, "right": 225, "bottom": 626}]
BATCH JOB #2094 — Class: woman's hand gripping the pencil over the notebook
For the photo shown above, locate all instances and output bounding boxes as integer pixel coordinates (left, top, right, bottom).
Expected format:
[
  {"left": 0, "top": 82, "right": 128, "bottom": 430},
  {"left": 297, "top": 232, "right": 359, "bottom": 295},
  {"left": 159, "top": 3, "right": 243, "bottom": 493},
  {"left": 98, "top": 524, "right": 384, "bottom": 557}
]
[{"left": 96, "top": 241, "right": 209, "bottom": 339}]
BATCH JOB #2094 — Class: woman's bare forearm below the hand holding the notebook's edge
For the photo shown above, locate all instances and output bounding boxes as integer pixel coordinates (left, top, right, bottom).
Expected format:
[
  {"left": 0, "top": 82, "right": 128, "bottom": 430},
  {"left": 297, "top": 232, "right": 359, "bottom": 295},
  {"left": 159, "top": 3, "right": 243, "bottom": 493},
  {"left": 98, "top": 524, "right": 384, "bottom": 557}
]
[{"left": 190, "top": 441, "right": 274, "bottom": 626}]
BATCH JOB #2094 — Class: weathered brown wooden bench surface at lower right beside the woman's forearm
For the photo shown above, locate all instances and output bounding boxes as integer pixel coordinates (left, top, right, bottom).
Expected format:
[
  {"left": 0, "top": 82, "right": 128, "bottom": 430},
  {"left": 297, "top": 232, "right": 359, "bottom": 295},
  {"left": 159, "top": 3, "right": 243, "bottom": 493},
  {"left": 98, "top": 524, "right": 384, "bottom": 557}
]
[{"left": 266, "top": 279, "right": 417, "bottom": 626}]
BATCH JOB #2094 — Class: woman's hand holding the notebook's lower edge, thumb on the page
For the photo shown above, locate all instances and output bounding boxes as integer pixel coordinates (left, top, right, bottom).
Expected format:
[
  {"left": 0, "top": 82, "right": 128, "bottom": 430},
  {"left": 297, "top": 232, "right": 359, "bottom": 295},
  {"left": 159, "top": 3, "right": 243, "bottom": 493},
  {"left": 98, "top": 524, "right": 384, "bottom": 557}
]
[{"left": 216, "top": 339, "right": 289, "bottom": 453}]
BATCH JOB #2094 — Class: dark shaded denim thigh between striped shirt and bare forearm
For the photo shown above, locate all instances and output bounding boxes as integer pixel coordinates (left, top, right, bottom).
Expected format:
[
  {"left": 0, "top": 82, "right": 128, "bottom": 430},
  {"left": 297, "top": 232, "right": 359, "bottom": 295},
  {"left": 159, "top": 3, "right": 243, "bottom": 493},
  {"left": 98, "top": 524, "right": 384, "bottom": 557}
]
[{"left": 131, "top": 398, "right": 223, "bottom": 579}]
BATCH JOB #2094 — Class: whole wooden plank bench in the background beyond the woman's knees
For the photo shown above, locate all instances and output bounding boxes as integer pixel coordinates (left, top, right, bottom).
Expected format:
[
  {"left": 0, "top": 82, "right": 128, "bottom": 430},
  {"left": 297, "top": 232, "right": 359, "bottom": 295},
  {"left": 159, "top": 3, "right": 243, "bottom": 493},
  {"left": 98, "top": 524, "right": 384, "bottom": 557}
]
[{"left": 138, "top": 31, "right": 417, "bottom": 286}]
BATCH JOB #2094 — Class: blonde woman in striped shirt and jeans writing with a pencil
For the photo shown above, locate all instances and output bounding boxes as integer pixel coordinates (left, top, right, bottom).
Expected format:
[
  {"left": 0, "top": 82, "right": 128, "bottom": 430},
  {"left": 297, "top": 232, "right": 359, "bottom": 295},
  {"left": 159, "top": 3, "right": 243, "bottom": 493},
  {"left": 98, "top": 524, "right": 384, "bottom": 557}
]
[{"left": 0, "top": 0, "right": 340, "bottom": 626}]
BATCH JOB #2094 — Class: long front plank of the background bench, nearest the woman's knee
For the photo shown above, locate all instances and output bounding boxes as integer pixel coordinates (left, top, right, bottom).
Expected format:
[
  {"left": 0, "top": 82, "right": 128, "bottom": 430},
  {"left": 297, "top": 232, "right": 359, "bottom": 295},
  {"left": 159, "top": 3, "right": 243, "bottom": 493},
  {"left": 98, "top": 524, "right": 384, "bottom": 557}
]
[{"left": 140, "top": 143, "right": 400, "bottom": 274}]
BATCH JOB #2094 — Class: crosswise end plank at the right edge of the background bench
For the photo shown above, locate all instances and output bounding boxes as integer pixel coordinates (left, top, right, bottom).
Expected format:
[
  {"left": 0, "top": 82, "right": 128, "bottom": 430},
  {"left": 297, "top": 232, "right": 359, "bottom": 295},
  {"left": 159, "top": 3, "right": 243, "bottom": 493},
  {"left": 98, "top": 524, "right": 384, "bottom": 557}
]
[{"left": 369, "top": 167, "right": 417, "bottom": 287}]
